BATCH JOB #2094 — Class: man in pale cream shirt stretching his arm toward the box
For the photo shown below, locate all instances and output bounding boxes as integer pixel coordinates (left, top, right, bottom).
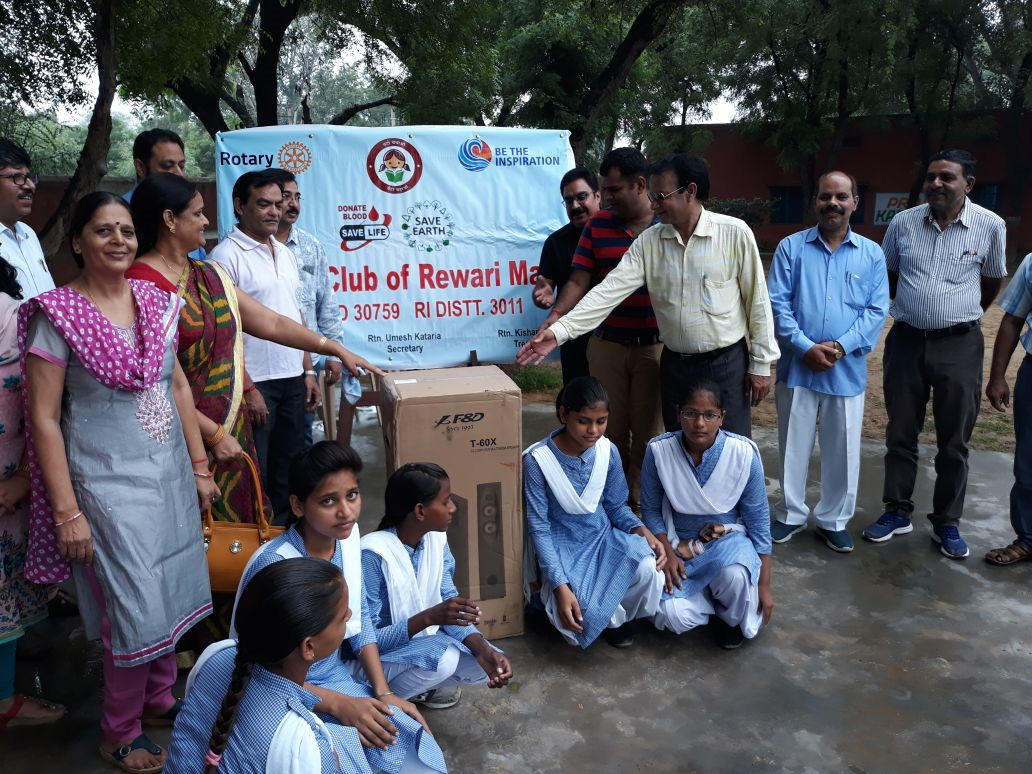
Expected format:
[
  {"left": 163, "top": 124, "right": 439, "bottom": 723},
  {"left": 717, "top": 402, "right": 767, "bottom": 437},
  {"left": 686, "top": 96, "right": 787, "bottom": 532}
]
[{"left": 517, "top": 154, "right": 778, "bottom": 437}]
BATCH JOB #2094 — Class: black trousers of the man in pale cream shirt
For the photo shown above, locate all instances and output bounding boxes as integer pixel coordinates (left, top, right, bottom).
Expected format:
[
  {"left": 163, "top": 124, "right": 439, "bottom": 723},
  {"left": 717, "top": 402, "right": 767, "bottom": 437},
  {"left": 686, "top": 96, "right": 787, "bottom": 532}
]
[{"left": 659, "top": 338, "right": 752, "bottom": 438}]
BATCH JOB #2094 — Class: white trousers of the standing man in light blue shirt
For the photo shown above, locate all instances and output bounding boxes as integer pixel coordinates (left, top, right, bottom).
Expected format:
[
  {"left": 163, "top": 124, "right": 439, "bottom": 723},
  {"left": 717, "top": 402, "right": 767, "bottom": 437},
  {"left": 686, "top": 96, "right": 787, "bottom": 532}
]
[{"left": 774, "top": 382, "right": 864, "bottom": 531}]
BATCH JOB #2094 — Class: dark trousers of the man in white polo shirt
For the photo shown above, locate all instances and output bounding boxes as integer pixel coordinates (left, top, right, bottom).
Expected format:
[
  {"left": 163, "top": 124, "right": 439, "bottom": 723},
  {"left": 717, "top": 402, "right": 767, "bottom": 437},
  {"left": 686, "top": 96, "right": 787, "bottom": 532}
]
[{"left": 254, "top": 376, "right": 305, "bottom": 523}]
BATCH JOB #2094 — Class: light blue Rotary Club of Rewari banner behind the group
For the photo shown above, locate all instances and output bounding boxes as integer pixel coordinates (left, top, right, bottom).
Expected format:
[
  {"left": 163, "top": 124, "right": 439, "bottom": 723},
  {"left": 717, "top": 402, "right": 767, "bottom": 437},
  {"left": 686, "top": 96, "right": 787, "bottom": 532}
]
[{"left": 215, "top": 125, "right": 574, "bottom": 368}]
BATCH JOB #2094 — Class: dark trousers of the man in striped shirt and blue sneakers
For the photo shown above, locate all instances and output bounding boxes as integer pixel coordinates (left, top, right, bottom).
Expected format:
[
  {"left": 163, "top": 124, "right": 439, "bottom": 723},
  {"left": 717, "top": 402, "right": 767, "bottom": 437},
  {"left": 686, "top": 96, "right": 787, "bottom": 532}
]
[{"left": 882, "top": 323, "right": 985, "bottom": 526}]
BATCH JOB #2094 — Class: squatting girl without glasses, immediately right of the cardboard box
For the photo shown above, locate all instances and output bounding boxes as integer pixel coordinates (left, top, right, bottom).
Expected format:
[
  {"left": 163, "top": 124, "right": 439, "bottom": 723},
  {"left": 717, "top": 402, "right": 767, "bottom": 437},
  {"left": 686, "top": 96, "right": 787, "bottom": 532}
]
[{"left": 523, "top": 377, "right": 666, "bottom": 648}]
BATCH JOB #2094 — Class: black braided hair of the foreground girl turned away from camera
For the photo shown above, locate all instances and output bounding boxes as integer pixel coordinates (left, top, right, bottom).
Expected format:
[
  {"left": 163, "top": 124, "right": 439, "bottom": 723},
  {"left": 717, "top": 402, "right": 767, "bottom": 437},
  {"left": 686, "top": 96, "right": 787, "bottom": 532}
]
[{"left": 204, "top": 556, "right": 346, "bottom": 774}]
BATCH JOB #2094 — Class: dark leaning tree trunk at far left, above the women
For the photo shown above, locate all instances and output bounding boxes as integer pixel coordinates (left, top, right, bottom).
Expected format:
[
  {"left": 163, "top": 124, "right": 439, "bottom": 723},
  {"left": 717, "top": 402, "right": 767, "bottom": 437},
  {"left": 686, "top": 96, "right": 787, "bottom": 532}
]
[{"left": 39, "top": 0, "right": 117, "bottom": 261}]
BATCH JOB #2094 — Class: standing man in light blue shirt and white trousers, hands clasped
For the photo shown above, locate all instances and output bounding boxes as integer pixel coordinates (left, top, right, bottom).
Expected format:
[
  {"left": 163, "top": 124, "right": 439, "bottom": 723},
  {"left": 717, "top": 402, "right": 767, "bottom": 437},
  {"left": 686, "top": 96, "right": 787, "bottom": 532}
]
[{"left": 767, "top": 171, "right": 889, "bottom": 553}]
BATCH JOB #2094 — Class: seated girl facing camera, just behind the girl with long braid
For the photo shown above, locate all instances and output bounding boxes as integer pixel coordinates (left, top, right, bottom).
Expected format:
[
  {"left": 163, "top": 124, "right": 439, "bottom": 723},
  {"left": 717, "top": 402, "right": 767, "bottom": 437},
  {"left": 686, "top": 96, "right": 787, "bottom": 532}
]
[{"left": 230, "top": 441, "right": 448, "bottom": 774}]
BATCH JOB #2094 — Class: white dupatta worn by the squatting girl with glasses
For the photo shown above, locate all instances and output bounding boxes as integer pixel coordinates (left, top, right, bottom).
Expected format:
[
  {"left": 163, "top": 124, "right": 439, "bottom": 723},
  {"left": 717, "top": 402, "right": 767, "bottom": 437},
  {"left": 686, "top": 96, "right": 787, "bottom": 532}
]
[{"left": 649, "top": 432, "right": 760, "bottom": 548}]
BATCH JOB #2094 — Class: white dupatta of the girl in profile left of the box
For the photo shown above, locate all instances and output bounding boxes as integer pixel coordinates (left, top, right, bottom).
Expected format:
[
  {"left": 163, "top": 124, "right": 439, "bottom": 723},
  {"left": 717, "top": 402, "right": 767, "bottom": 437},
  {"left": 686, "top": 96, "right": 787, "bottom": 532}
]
[{"left": 362, "top": 529, "right": 448, "bottom": 637}]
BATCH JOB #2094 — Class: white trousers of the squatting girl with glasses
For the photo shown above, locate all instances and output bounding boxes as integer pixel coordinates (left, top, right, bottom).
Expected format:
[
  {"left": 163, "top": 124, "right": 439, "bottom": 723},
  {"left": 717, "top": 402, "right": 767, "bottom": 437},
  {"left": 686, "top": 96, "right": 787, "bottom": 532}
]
[{"left": 652, "top": 565, "right": 764, "bottom": 640}]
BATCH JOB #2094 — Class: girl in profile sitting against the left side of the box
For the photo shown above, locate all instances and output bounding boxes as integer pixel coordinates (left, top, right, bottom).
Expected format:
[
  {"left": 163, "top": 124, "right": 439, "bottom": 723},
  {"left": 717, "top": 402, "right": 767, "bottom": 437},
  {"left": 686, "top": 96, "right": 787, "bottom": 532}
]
[{"left": 362, "top": 462, "right": 512, "bottom": 709}]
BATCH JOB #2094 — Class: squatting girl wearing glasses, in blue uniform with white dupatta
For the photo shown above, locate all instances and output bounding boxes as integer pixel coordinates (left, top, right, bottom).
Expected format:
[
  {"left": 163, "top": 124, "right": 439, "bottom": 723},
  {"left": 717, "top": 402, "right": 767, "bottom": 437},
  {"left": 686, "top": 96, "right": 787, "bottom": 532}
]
[{"left": 641, "top": 380, "right": 774, "bottom": 648}]
